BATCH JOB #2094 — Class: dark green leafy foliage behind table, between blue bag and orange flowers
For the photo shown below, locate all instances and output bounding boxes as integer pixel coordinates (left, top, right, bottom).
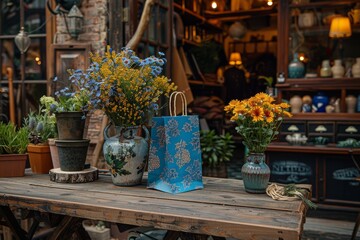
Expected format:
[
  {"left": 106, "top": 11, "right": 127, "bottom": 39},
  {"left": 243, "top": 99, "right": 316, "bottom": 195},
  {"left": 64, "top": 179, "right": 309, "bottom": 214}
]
[{"left": 200, "top": 130, "right": 235, "bottom": 168}]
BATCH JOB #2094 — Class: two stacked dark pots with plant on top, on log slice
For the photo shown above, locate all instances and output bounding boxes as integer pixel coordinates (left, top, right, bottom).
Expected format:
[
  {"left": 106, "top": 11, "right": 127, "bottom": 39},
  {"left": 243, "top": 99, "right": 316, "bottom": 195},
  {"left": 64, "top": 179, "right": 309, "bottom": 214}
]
[{"left": 41, "top": 76, "right": 90, "bottom": 172}]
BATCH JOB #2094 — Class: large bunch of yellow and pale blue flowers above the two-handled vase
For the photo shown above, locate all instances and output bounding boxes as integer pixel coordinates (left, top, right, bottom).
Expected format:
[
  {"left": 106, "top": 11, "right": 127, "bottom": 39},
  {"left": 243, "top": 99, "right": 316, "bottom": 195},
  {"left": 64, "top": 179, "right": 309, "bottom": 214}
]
[{"left": 79, "top": 47, "right": 176, "bottom": 127}]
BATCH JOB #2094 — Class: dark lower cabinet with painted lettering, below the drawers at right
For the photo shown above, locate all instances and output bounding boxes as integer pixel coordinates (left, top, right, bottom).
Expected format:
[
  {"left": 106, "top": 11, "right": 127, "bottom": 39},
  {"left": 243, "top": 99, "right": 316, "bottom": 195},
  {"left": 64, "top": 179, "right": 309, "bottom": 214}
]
[{"left": 266, "top": 142, "right": 360, "bottom": 208}]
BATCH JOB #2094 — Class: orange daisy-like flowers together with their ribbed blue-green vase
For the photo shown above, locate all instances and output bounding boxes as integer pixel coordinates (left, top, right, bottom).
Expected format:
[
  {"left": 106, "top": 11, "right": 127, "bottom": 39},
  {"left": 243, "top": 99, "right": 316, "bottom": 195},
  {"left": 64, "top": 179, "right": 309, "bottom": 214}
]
[{"left": 225, "top": 93, "right": 291, "bottom": 193}]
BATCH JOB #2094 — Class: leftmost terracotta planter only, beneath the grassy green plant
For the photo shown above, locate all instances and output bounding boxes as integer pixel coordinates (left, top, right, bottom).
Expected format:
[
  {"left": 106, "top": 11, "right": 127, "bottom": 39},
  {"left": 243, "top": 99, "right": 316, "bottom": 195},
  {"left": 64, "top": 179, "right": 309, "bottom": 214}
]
[{"left": 0, "top": 154, "right": 28, "bottom": 177}]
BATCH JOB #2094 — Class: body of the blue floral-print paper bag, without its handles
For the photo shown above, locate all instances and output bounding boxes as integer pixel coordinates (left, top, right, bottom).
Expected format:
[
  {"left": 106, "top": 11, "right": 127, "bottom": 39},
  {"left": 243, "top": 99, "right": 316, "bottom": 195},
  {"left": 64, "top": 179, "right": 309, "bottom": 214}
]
[{"left": 148, "top": 92, "right": 203, "bottom": 194}]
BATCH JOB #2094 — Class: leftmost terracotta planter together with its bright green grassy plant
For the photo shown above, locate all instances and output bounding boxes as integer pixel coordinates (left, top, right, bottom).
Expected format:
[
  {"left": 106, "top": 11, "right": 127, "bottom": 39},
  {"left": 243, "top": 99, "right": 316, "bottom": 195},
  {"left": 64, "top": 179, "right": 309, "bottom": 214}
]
[{"left": 0, "top": 122, "right": 29, "bottom": 177}]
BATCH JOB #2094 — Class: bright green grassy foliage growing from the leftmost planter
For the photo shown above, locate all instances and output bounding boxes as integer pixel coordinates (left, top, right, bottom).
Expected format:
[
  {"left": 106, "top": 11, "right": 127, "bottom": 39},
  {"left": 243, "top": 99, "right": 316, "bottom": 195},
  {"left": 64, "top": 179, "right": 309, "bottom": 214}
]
[{"left": 0, "top": 122, "right": 29, "bottom": 154}]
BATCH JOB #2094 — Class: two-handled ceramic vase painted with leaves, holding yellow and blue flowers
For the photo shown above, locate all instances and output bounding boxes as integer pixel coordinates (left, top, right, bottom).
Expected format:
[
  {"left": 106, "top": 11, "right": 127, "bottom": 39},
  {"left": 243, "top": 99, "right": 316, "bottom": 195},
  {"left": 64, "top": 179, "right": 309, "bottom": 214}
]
[{"left": 103, "top": 123, "right": 149, "bottom": 186}]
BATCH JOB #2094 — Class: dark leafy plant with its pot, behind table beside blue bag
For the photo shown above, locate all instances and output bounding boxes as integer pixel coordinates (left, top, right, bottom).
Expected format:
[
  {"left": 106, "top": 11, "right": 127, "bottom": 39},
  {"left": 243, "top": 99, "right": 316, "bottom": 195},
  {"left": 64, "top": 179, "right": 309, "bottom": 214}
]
[{"left": 200, "top": 130, "right": 235, "bottom": 177}]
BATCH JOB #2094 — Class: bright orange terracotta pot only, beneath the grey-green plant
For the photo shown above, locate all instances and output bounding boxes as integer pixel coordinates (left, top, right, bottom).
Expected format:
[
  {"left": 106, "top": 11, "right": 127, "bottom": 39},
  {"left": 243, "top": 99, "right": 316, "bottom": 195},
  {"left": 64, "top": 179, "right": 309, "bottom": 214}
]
[{"left": 27, "top": 144, "right": 53, "bottom": 174}]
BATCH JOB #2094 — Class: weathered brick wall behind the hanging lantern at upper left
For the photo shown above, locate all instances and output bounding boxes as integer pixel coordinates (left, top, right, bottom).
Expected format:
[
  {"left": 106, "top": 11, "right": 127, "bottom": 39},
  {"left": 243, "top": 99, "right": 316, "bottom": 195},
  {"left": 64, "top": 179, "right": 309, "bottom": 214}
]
[{"left": 55, "top": 0, "right": 108, "bottom": 52}]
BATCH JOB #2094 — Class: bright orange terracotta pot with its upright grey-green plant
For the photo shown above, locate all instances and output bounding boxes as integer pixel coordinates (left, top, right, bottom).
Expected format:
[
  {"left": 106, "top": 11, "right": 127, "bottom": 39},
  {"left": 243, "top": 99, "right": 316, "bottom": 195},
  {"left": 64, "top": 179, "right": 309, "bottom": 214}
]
[{"left": 24, "top": 108, "right": 57, "bottom": 174}]
